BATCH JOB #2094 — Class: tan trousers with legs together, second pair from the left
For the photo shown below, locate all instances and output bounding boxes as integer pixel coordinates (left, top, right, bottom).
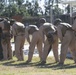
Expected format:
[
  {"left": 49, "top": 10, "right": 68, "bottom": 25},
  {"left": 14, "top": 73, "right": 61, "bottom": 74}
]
[{"left": 15, "top": 35, "right": 25, "bottom": 61}]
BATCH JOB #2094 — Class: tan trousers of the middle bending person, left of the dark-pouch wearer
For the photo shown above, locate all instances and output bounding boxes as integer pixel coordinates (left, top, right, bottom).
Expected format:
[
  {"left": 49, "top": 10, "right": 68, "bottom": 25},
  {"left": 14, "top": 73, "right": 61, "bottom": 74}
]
[{"left": 28, "top": 31, "right": 42, "bottom": 61}]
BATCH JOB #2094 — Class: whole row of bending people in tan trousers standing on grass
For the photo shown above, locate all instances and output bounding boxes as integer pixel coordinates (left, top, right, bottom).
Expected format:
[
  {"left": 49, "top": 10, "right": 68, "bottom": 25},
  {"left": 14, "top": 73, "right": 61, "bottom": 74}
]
[{"left": 0, "top": 18, "right": 76, "bottom": 65}]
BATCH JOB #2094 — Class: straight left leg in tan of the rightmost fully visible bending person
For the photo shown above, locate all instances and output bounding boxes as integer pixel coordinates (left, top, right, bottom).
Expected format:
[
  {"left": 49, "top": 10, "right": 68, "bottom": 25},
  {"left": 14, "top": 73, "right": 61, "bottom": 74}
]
[{"left": 59, "top": 31, "right": 72, "bottom": 64}]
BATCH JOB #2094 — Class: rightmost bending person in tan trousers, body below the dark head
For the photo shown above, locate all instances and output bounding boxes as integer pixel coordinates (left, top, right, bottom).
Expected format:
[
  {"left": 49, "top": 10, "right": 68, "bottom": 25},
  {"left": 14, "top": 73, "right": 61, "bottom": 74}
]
[{"left": 54, "top": 18, "right": 76, "bottom": 65}]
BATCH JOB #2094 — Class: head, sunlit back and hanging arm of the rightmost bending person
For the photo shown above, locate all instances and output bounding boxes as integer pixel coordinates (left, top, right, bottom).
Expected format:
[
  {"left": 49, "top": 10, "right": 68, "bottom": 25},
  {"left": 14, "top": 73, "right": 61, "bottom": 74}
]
[{"left": 54, "top": 19, "right": 72, "bottom": 42}]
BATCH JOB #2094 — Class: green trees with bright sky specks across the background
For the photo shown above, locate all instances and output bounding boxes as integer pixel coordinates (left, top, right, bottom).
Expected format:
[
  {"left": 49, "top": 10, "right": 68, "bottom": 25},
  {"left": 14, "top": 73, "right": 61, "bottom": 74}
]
[{"left": 0, "top": 0, "right": 64, "bottom": 17}]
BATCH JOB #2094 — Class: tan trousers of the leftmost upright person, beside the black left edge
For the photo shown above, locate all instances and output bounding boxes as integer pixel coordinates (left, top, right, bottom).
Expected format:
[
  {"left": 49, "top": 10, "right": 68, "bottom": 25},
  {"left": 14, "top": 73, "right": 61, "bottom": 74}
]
[{"left": 1, "top": 38, "right": 13, "bottom": 60}]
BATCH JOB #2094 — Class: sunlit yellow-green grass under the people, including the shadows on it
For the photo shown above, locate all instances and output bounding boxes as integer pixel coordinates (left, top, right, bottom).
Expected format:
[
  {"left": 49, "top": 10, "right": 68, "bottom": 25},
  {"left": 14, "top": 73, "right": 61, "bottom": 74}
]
[{"left": 0, "top": 56, "right": 76, "bottom": 75}]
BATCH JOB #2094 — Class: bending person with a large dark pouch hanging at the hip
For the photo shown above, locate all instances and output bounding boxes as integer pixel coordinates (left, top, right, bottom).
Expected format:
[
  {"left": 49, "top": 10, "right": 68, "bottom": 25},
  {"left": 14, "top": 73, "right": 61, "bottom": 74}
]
[{"left": 39, "top": 23, "right": 59, "bottom": 64}]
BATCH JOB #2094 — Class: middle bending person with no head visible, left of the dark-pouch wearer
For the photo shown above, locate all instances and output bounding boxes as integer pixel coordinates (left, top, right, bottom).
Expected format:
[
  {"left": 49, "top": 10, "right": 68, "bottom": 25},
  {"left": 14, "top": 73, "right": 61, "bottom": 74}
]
[{"left": 26, "top": 25, "right": 42, "bottom": 63}]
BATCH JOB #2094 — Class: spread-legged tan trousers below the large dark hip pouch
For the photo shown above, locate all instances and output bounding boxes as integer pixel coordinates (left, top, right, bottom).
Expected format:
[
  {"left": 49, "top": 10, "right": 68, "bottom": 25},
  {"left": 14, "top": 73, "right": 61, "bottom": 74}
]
[{"left": 42, "top": 35, "right": 59, "bottom": 62}]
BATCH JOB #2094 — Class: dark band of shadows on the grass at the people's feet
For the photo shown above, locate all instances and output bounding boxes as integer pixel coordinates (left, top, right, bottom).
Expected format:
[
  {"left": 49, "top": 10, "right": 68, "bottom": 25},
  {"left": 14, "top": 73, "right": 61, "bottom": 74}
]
[{"left": 0, "top": 60, "right": 76, "bottom": 70}]
